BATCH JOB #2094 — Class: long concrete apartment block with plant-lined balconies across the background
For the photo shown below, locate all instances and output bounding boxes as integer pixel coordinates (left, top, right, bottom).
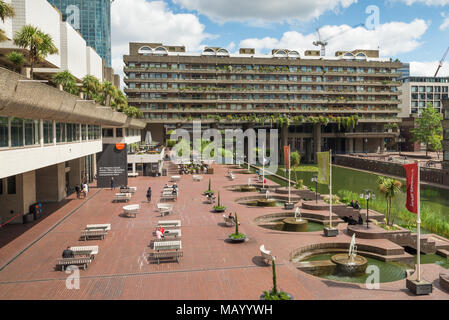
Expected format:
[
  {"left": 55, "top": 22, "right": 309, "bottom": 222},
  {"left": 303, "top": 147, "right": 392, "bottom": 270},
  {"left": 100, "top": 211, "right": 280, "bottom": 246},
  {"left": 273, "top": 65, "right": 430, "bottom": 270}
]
[{"left": 123, "top": 43, "right": 402, "bottom": 160}]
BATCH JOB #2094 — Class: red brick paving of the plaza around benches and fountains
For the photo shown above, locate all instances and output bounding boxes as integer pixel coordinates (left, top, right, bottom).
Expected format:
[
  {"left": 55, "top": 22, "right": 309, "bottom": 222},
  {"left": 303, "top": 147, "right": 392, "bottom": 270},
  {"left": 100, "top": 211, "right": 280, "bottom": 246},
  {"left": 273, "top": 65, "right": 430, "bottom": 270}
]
[{"left": 0, "top": 166, "right": 449, "bottom": 299}]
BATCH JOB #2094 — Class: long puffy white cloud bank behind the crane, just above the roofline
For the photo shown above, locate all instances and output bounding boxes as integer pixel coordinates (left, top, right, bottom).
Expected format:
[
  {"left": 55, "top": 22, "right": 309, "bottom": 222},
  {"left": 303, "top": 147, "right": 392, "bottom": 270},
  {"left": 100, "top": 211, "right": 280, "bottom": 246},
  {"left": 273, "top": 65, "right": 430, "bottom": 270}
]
[{"left": 240, "top": 19, "right": 428, "bottom": 57}]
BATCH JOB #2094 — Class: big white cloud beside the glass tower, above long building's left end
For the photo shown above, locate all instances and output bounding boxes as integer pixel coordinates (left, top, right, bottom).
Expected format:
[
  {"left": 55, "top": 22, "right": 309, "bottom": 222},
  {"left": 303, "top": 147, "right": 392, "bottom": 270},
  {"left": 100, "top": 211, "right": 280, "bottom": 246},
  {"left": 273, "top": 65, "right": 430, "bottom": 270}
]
[{"left": 111, "top": 0, "right": 213, "bottom": 87}]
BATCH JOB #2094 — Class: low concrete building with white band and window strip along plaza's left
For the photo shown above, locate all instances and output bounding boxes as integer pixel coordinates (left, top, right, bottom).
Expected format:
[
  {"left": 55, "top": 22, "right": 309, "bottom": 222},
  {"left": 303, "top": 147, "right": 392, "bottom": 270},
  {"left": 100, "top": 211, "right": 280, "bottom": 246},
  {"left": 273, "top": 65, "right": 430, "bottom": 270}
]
[{"left": 0, "top": 68, "right": 145, "bottom": 223}]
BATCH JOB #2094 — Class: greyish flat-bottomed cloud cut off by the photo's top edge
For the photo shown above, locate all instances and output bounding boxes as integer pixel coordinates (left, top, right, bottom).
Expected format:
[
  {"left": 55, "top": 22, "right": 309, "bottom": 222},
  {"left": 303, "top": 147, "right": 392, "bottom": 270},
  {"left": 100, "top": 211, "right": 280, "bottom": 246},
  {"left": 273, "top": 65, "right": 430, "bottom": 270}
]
[{"left": 173, "top": 0, "right": 358, "bottom": 24}]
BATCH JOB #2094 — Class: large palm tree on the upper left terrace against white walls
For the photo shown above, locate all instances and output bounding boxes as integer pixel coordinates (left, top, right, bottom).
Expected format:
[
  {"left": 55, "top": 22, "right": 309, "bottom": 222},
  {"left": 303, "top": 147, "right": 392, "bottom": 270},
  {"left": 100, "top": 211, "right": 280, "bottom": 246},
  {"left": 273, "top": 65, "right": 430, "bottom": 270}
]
[{"left": 14, "top": 25, "right": 58, "bottom": 79}]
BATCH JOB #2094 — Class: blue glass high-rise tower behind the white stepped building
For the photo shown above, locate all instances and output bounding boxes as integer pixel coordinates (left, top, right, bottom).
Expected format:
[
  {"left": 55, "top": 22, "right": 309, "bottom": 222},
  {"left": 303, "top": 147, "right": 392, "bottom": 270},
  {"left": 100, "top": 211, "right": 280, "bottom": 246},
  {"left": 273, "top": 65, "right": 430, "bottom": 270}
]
[{"left": 48, "top": 0, "right": 112, "bottom": 67}]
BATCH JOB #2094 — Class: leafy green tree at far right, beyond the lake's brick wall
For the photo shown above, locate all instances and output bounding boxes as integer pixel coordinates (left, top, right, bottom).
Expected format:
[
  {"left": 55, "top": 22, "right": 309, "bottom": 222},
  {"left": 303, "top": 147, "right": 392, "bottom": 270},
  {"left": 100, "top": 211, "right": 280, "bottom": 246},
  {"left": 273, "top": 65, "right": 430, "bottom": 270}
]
[{"left": 410, "top": 103, "right": 443, "bottom": 156}]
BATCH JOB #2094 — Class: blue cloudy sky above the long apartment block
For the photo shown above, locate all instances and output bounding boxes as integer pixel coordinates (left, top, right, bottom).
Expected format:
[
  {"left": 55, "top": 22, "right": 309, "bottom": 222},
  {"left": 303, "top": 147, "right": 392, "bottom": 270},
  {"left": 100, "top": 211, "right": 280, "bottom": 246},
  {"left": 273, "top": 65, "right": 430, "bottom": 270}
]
[{"left": 112, "top": 0, "right": 449, "bottom": 76}]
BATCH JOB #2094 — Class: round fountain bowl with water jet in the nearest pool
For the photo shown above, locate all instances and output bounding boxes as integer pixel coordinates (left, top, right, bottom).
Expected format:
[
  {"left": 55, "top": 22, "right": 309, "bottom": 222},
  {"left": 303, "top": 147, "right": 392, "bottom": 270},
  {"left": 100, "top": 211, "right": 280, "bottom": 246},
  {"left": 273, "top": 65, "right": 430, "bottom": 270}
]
[{"left": 331, "top": 234, "right": 368, "bottom": 276}]
